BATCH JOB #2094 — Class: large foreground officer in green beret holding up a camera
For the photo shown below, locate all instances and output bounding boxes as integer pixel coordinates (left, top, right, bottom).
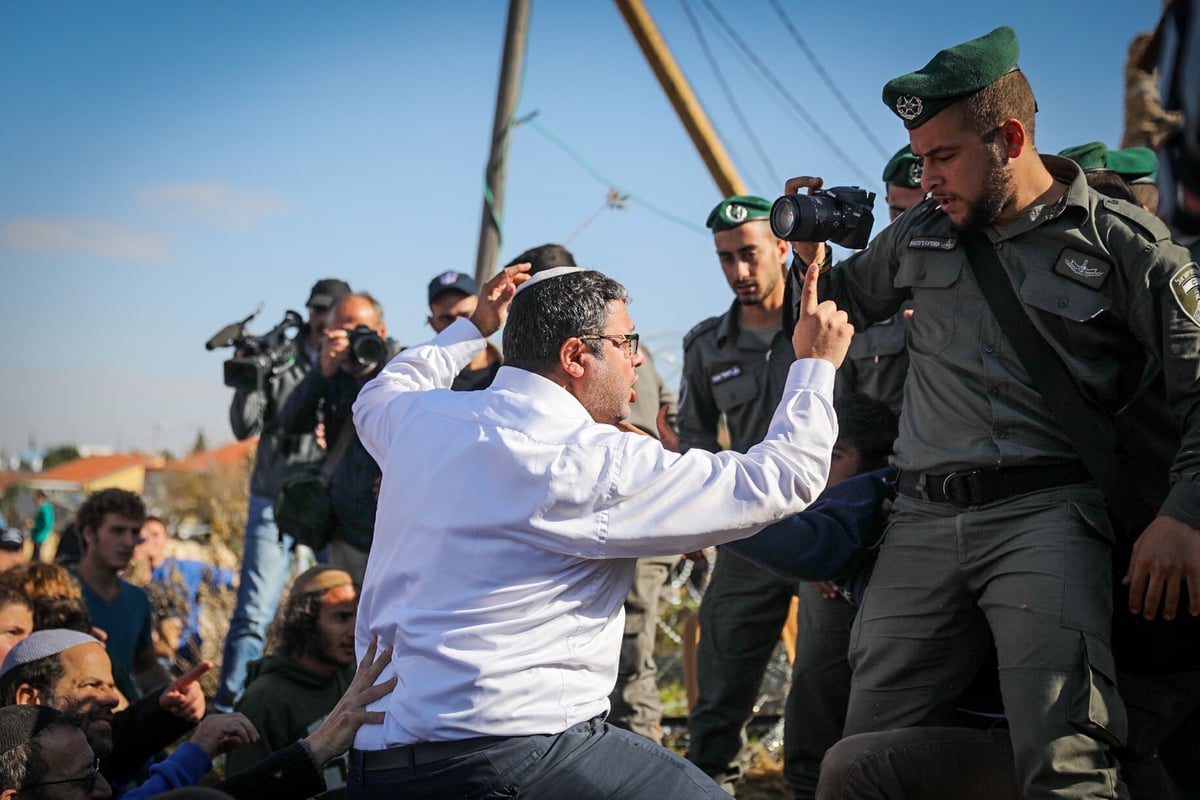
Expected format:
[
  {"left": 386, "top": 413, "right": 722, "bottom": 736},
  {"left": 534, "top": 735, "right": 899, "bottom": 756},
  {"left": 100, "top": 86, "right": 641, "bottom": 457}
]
[{"left": 787, "top": 28, "right": 1200, "bottom": 798}]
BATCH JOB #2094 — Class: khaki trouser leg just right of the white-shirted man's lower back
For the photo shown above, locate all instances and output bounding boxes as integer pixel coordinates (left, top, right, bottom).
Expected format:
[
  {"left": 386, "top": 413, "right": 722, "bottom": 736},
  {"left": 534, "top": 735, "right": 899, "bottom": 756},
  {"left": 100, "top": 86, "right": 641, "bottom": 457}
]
[{"left": 608, "top": 555, "right": 679, "bottom": 745}]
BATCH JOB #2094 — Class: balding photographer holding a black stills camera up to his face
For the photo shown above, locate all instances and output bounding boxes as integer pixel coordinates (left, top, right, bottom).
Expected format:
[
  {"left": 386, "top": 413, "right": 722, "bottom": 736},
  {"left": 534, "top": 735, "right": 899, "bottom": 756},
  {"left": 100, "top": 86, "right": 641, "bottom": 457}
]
[{"left": 280, "top": 293, "right": 401, "bottom": 585}]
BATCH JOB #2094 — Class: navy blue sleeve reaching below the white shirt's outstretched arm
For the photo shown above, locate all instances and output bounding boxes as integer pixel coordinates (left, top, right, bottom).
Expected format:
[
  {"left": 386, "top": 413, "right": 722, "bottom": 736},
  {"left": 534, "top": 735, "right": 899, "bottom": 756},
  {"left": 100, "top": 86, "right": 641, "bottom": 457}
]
[{"left": 722, "top": 468, "right": 895, "bottom": 581}]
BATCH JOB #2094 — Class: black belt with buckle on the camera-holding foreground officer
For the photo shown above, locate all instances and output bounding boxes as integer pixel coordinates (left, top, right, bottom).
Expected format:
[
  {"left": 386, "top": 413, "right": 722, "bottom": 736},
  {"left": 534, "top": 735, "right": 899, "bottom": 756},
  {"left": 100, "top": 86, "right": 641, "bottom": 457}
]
[{"left": 896, "top": 461, "right": 1094, "bottom": 509}]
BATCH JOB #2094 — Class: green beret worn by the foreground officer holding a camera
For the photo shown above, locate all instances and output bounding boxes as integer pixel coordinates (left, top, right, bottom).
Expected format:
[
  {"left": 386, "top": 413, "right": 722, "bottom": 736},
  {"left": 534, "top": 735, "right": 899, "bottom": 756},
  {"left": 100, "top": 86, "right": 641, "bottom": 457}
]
[{"left": 883, "top": 25, "right": 1020, "bottom": 131}]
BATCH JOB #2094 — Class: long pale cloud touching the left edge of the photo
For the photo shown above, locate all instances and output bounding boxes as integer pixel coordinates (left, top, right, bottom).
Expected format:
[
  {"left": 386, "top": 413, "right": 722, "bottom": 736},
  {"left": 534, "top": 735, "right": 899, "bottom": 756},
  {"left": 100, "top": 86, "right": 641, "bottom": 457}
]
[{"left": 0, "top": 216, "right": 169, "bottom": 263}]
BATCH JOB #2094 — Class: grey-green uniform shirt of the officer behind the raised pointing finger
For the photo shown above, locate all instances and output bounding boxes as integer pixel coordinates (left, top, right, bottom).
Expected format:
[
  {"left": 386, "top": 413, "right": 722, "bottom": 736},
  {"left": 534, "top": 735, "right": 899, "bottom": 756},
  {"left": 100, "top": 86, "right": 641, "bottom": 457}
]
[{"left": 678, "top": 301, "right": 796, "bottom": 452}]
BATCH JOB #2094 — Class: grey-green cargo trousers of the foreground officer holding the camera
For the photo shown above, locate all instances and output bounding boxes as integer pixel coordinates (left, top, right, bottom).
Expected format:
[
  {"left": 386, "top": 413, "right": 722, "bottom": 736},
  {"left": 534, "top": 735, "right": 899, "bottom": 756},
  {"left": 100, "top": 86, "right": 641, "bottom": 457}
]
[{"left": 846, "top": 486, "right": 1128, "bottom": 799}]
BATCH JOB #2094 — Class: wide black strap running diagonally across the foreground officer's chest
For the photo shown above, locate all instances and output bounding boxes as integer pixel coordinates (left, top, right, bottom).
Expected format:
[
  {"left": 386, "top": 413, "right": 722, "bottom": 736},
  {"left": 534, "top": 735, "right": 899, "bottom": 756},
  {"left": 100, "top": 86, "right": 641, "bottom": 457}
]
[{"left": 959, "top": 230, "right": 1154, "bottom": 536}]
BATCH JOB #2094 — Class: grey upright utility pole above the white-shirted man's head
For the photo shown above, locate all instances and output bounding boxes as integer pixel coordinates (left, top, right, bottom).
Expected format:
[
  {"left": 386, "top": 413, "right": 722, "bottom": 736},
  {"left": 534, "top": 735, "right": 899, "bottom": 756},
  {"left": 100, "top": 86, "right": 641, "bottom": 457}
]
[{"left": 475, "top": 0, "right": 532, "bottom": 285}]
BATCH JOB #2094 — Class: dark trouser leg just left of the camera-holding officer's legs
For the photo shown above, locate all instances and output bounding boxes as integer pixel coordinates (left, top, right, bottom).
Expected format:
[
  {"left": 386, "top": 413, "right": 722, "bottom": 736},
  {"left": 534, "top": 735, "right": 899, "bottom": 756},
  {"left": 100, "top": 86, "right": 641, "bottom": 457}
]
[{"left": 784, "top": 583, "right": 856, "bottom": 800}]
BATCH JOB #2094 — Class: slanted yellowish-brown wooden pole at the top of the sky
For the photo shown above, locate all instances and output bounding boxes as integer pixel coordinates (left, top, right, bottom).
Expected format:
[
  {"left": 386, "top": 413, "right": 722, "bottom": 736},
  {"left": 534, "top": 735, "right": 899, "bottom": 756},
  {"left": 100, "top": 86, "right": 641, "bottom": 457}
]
[{"left": 616, "top": 0, "right": 748, "bottom": 197}]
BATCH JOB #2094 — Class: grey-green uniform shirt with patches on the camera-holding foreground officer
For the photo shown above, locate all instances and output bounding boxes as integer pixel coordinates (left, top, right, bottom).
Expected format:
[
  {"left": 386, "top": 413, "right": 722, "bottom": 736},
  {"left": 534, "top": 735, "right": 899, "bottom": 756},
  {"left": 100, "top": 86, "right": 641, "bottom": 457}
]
[{"left": 820, "top": 156, "right": 1200, "bottom": 525}]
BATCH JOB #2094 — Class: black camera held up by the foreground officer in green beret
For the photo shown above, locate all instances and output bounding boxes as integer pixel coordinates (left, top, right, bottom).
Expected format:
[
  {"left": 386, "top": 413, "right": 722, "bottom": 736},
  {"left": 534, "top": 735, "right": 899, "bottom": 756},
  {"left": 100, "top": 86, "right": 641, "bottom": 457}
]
[{"left": 770, "top": 186, "right": 875, "bottom": 249}]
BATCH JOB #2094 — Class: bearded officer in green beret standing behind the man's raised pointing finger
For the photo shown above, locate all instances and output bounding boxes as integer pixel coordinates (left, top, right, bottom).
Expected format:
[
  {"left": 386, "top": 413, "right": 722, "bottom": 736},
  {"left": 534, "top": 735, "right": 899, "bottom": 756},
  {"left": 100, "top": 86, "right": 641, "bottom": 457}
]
[{"left": 678, "top": 197, "right": 796, "bottom": 790}]
